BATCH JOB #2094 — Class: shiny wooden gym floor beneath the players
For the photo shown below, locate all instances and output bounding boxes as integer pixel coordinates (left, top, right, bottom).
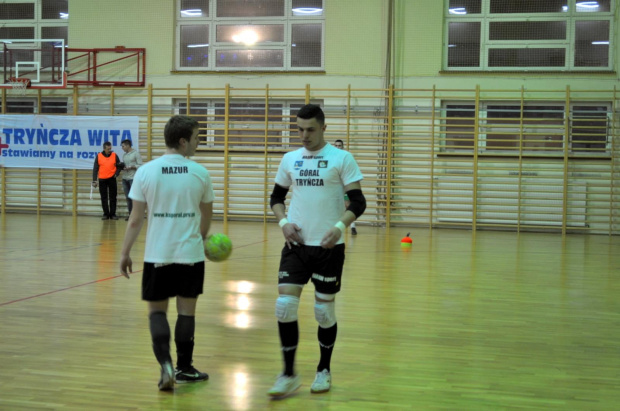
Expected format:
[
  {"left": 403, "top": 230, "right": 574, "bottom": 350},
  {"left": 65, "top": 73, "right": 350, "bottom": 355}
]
[{"left": 0, "top": 214, "right": 620, "bottom": 410}]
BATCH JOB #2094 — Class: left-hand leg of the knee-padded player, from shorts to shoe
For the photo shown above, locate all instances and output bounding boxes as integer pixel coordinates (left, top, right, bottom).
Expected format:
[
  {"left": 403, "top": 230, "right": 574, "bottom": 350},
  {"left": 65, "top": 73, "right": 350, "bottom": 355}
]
[{"left": 268, "top": 246, "right": 311, "bottom": 397}]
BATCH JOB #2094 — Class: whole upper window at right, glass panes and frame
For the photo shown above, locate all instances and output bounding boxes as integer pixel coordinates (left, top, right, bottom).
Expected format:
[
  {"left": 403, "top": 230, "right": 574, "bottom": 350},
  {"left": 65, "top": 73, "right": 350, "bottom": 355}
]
[{"left": 444, "top": 0, "right": 615, "bottom": 71}]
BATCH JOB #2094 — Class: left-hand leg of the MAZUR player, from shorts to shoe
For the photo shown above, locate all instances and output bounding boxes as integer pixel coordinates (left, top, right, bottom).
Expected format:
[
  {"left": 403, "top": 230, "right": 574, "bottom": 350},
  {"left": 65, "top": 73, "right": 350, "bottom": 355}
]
[{"left": 142, "top": 262, "right": 174, "bottom": 391}]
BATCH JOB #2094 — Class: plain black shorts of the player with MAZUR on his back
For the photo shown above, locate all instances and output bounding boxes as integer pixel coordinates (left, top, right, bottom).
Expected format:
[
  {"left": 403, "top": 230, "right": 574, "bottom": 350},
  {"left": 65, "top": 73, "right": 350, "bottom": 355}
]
[{"left": 142, "top": 261, "right": 205, "bottom": 301}]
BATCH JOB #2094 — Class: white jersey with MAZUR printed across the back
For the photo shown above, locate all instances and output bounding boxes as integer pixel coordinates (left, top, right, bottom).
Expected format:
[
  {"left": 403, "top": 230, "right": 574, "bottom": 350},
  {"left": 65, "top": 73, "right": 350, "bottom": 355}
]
[{"left": 129, "top": 154, "right": 214, "bottom": 264}]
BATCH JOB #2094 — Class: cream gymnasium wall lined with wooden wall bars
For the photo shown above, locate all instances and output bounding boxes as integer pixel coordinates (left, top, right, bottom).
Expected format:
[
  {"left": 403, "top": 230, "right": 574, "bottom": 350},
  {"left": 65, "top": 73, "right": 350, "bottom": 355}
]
[{"left": 0, "top": 0, "right": 620, "bottom": 234}]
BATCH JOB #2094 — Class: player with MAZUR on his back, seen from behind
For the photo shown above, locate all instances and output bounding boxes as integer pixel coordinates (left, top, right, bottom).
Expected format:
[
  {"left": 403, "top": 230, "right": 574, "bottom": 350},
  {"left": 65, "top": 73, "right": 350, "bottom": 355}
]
[{"left": 120, "top": 116, "right": 213, "bottom": 390}]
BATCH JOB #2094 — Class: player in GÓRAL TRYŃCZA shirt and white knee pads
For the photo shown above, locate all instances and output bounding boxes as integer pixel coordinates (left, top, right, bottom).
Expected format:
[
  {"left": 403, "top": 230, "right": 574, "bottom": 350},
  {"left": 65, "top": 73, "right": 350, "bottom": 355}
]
[{"left": 268, "top": 104, "right": 366, "bottom": 397}]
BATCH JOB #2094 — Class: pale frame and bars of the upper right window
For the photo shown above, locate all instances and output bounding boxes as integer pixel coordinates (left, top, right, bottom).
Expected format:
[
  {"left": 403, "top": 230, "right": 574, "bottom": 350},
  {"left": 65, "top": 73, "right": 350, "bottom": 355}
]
[{"left": 442, "top": 0, "right": 617, "bottom": 72}]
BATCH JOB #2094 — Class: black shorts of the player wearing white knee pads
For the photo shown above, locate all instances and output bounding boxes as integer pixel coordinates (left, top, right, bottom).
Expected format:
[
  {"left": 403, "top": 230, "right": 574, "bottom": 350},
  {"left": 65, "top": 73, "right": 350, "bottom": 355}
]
[{"left": 278, "top": 243, "right": 345, "bottom": 294}]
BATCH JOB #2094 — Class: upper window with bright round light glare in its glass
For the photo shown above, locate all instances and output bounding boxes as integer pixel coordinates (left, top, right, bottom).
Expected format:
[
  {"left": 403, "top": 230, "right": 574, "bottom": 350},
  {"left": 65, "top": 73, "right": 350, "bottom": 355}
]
[{"left": 176, "top": 0, "right": 325, "bottom": 71}]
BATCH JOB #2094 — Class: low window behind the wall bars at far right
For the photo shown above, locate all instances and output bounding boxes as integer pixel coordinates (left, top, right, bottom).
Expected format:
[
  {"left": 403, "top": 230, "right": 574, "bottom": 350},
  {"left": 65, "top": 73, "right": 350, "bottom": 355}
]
[{"left": 442, "top": 101, "right": 612, "bottom": 157}]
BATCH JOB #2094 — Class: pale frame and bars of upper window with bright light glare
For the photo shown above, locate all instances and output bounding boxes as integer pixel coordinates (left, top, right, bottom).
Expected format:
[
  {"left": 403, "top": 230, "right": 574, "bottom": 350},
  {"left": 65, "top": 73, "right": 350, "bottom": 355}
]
[{"left": 174, "top": 0, "right": 326, "bottom": 72}]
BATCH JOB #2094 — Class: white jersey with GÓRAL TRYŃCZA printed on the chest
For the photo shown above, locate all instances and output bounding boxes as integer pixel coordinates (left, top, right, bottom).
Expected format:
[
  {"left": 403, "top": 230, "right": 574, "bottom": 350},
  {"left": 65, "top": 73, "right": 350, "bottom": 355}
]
[{"left": 276, "top": 144, "right": 364, "bottom": 246}]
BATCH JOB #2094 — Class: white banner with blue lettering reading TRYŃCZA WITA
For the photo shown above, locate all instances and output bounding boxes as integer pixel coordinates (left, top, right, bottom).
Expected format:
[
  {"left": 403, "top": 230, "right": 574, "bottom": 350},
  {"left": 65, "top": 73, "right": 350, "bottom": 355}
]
[{"left": 0, "top": 115, "right": 139, "bottom": 170}]
